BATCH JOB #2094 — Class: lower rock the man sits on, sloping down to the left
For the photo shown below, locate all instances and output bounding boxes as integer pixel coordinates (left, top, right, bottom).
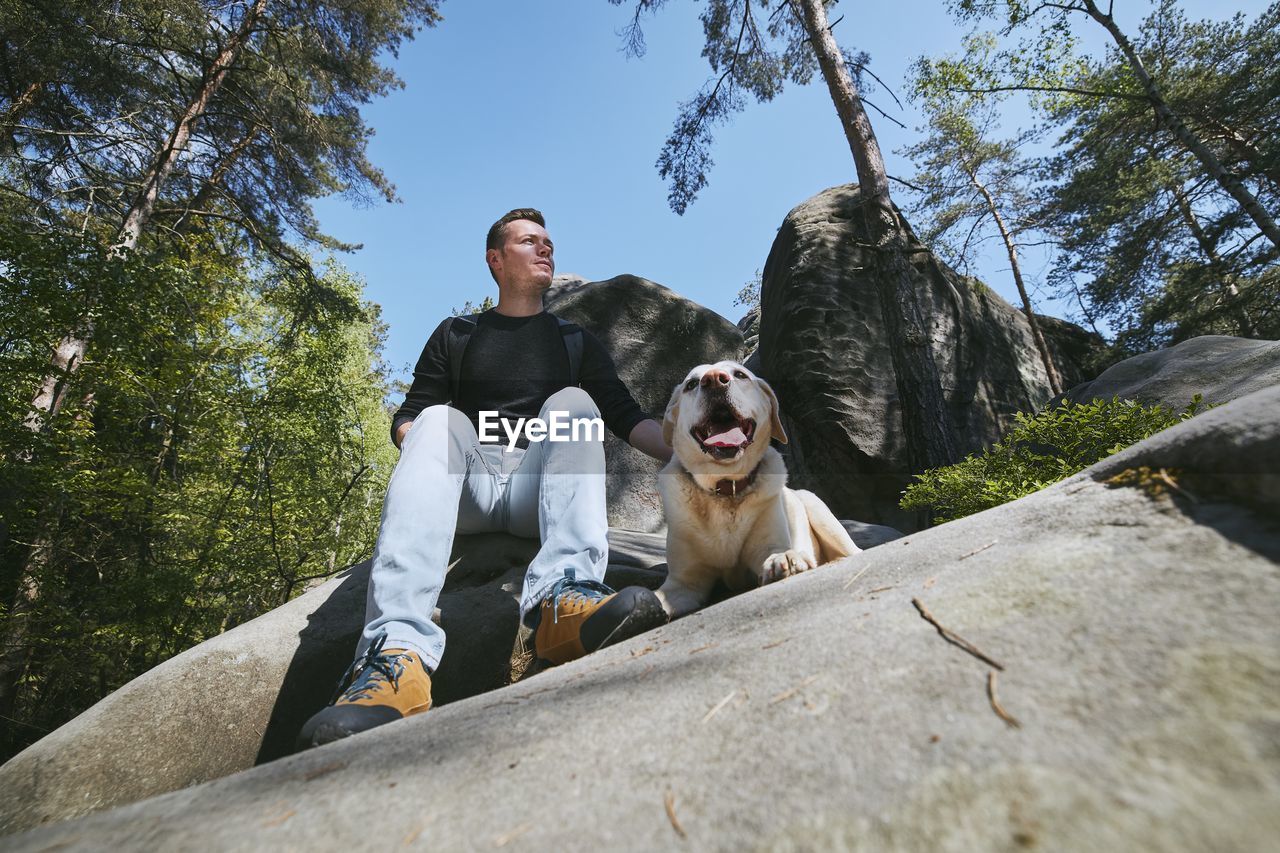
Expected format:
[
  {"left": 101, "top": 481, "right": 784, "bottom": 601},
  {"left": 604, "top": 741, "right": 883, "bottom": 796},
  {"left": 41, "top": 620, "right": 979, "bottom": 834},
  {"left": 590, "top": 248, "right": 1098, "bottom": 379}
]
[{"left": 0, "top": 530, "right": 667, "bottom": 833}]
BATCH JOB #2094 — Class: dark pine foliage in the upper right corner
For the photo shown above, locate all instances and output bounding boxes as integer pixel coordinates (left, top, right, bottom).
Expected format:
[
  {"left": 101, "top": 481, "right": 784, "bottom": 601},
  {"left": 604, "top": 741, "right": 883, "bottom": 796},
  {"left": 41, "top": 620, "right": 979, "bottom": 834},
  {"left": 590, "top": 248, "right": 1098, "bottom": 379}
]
[{"left": 1044, "top": 0, "right": 1280, "bottom": 353}]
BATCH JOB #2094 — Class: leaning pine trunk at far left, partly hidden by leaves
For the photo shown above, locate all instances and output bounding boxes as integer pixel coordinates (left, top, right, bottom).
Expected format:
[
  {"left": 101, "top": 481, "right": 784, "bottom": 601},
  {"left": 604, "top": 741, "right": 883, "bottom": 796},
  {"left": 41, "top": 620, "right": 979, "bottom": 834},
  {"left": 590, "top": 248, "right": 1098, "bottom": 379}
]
[{"left": 0, "top": 0, "right": 266, "bottom": 715}]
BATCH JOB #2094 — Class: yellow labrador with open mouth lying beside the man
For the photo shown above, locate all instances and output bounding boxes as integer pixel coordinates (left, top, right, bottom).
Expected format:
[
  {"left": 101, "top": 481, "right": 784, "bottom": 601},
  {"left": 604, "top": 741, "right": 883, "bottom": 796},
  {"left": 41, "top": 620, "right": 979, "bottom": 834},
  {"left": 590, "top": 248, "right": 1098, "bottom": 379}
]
[{"left": 658, "top": 361, "right": 858, "bottom": 617}]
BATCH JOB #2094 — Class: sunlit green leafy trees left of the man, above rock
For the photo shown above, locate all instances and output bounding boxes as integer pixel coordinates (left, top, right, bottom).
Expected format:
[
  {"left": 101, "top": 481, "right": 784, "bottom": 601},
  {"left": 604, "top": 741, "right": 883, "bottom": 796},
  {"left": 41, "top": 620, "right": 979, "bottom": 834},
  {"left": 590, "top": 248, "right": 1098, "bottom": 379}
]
[{"left": 0, "top": 220, "right": 396, "bottom": 756}]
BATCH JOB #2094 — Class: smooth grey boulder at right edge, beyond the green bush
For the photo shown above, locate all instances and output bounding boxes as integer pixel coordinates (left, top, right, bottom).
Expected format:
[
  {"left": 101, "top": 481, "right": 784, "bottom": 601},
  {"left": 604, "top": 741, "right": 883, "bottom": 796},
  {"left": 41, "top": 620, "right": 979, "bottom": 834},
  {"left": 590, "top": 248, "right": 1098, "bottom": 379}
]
[{"left": 1065, "top": 334, "right": 1280, "bottom": 409}]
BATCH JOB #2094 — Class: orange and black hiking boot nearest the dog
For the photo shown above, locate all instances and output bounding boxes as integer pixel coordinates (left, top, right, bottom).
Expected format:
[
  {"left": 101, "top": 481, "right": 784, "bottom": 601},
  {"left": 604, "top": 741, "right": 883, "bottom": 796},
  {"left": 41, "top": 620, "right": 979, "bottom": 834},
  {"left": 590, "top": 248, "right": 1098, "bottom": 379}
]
[{"left": 534, "top": 569, "right": 667, "bottom": 663}]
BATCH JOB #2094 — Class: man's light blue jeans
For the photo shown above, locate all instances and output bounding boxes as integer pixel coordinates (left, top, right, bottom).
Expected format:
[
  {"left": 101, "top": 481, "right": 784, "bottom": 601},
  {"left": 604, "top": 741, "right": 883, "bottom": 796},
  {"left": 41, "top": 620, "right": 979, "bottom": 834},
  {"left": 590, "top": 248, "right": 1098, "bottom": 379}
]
[{"left": 356, "top": 388, "right": 609, "bottom": 670}]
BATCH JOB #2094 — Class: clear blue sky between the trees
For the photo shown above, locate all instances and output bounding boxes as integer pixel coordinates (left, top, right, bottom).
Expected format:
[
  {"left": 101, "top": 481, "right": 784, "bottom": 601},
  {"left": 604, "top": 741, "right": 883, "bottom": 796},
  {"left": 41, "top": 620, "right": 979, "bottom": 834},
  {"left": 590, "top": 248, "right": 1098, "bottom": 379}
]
[{"left": 316, "top": 0, "right": 1266, "bottom": 379}]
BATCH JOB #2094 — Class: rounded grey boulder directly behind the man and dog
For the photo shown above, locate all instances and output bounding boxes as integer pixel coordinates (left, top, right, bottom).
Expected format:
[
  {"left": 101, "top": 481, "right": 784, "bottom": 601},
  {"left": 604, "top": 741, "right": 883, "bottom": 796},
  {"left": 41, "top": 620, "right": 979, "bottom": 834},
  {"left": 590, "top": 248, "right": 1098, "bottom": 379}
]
[{"left": 544, "top": 275, "right": 742, "bottom": 532}]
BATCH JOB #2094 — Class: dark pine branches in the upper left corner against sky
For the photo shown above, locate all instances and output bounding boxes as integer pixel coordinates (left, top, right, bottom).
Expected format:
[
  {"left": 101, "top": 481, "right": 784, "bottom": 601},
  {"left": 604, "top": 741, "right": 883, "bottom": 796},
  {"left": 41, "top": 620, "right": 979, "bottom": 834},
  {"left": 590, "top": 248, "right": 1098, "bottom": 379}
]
[{"left": 0, "top": 0, "right": 439, "bottom": 255}]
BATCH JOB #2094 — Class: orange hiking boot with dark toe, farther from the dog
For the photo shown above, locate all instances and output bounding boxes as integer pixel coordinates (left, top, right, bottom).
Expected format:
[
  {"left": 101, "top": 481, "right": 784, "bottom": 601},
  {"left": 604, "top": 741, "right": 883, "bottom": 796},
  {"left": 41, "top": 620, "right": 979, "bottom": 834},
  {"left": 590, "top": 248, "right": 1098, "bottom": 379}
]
[{"left": 297, "top": 634, "right": 431, "bottom": 749}]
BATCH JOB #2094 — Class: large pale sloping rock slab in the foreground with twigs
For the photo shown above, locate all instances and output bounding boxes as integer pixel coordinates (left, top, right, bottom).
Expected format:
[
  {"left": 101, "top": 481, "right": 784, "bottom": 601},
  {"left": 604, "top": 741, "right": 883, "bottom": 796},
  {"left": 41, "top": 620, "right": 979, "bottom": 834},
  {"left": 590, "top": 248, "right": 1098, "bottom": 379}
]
[{"left": 5, "top": 388, "right": 1280, "bottom": 850}]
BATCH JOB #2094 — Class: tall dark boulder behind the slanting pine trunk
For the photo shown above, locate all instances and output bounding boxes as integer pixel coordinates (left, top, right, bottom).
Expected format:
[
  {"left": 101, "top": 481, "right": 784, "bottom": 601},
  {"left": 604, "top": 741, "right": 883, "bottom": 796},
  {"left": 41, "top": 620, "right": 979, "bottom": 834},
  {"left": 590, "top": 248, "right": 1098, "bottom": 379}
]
[{"left": 756, "top": 184, "right": 1088, "bottom": 529}]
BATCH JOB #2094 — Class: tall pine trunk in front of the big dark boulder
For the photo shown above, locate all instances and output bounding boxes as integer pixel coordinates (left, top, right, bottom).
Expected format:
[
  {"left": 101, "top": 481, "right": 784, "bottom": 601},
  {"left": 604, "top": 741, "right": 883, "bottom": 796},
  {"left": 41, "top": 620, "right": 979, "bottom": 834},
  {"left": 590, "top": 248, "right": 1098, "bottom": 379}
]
[{"left": 788, "top": 0, "right": 957, "bottom": 473}]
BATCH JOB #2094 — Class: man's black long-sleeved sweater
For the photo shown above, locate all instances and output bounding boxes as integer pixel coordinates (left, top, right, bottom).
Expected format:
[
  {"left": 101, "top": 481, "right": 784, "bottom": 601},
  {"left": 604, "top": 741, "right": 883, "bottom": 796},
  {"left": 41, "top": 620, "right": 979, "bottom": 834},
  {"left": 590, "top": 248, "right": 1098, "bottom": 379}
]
[{"left": 392, "top": 310, "right": 649, "bottom": 447}]
